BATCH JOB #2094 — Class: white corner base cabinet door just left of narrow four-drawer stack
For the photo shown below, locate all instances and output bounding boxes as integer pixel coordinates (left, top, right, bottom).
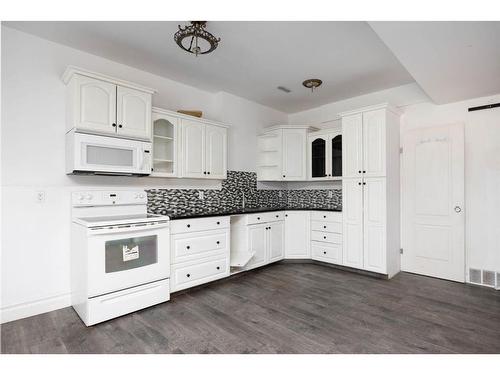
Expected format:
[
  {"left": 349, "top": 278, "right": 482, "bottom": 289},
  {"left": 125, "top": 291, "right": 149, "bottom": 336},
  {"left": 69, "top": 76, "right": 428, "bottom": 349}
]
[{"left": 285, "top": 211, "right": 311, "bottom": 259}]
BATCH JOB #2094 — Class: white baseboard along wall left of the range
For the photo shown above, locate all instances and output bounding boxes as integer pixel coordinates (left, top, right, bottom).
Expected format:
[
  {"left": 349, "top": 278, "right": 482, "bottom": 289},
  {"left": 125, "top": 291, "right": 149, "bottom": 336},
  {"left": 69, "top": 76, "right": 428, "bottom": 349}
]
[{"left": 0, "top": 293, "right": 71, "bottom": 323}]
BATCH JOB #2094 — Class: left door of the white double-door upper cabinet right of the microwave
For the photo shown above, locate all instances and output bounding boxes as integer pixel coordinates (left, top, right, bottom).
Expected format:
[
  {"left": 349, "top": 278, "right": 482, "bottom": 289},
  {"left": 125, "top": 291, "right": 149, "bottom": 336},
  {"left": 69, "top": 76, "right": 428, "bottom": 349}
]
[{"left": 181, "top": 120, "right": 207, "bottom": 178}]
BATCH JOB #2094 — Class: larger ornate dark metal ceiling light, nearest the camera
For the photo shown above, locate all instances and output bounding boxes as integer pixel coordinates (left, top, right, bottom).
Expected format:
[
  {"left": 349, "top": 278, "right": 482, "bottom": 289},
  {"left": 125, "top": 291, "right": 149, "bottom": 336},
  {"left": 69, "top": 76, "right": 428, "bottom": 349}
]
[{"left": 174, "top": 21, "right": 220, "bottom": 56}]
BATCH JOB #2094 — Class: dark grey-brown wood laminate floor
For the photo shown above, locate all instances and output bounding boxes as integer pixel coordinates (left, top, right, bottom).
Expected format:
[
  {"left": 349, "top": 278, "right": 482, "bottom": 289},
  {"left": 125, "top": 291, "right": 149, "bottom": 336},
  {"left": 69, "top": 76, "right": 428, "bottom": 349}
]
[{"left": 1, "top": 264, "right": 500, "bottom": 353}]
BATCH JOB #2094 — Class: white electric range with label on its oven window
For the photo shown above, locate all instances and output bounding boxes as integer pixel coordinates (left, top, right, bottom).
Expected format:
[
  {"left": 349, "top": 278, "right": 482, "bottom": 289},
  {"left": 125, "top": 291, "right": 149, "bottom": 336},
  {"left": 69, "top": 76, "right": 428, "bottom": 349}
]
[{"left": 71, "top": 190, "right": 170, "bottom": 326}]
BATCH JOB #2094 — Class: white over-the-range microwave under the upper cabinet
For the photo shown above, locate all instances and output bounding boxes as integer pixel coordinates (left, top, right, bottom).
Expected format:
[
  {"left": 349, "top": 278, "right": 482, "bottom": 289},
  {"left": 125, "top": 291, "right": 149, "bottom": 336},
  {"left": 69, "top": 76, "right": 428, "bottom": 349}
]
[{"left": 66, "top": 130, "right": 152, "bottom": 176}]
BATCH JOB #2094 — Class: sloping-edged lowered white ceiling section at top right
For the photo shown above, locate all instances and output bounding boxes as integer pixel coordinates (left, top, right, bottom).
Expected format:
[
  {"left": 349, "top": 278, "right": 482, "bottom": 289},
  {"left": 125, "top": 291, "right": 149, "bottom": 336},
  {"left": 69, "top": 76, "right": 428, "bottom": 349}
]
[{"left": 370, "top": 22, "right": 500, "bottom": 104}]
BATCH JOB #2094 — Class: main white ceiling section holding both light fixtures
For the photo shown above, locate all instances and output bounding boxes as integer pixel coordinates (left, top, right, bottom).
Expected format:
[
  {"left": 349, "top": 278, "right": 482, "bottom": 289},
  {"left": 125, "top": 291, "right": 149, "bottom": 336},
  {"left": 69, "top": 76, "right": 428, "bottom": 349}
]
[{"left": 4, "top": 21, "right": 414, "bottom": 113}]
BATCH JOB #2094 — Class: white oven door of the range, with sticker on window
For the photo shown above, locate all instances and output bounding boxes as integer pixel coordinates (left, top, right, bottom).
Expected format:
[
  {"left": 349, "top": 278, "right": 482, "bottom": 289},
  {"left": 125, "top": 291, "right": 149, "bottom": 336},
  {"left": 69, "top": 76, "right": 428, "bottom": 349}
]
[{"left": 87, "top": 223, "right": 170, "bottom": 297}]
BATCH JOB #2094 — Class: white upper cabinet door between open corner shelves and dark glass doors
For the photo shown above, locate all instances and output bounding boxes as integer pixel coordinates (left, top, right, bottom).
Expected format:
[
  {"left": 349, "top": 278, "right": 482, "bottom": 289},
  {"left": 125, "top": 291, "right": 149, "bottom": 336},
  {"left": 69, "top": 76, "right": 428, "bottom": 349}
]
[{"left": 282, "top": 129, "right": 307, "bottom": 181}]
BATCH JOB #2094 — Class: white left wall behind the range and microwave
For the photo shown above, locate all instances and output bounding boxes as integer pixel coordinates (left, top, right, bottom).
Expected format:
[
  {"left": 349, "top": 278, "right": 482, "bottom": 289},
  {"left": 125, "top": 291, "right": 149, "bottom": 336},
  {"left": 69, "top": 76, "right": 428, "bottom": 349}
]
[{"left": 0, "top": 27, "right": 287, "bottom": 321}]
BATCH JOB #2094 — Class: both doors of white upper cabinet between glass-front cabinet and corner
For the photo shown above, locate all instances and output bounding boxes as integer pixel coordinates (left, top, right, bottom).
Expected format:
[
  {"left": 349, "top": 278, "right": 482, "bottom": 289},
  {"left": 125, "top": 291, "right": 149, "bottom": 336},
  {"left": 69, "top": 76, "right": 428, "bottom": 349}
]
[{"left": 181, "top": 119, "right": 227, "bottom": 179}]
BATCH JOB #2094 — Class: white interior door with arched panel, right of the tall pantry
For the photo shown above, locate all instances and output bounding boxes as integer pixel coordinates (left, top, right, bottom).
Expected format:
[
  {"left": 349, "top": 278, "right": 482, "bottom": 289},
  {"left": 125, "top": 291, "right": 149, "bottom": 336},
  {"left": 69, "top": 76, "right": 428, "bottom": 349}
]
[{"left": 401, "top": 124, "right": 465, "bottom": 282}]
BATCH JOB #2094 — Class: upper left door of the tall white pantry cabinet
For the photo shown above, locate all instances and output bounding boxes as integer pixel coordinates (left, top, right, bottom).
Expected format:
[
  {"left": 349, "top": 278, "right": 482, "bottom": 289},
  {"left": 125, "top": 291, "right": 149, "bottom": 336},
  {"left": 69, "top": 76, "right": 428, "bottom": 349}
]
[{"left": 342, "top": 113, "right": 363, "bottom": 178}]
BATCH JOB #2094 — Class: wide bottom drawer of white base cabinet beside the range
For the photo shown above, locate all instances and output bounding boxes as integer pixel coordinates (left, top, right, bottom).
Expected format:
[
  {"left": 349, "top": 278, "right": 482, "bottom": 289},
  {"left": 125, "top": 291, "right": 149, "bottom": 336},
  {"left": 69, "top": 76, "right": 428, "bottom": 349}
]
[{"left": 170, "top": 256, "right": 229, "bottom": 292}]
